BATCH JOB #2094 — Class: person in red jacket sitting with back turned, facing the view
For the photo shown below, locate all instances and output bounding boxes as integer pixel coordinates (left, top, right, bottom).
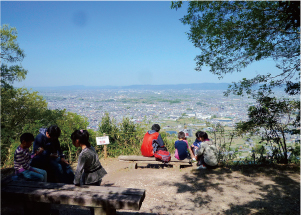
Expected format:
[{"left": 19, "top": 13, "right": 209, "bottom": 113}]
[{"left": 141, "top": 124, "right": 165, "bottom": 157}]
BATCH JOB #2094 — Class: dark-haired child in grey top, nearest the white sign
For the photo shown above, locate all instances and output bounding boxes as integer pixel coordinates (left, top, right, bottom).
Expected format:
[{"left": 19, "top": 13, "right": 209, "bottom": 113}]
[{"left": 71, "top": 130, "right": 107, "bottom": 186}]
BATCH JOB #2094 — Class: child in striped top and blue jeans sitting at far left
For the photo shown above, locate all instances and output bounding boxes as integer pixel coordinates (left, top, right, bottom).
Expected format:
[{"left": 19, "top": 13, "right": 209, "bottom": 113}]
[{"left": 14, "top": 133, "right": 47, "bottom": 182}]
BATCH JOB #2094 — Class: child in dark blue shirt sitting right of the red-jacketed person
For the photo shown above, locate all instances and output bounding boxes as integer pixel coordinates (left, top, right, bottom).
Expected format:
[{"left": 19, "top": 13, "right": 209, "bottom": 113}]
[{"left": 175, "top": 131, "right": 195, "bottom": 161}]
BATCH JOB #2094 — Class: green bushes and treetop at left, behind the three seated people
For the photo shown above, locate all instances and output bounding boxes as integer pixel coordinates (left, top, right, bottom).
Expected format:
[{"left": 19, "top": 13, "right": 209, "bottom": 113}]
[{"left": 0, "top": 25, "right": 90, "bottom": 166}]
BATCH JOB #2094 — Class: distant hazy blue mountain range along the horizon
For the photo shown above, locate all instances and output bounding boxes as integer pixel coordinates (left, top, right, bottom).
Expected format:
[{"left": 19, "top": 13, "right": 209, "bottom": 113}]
[{"left": 29, "top": 83, "right": 229, "bottom": 91}]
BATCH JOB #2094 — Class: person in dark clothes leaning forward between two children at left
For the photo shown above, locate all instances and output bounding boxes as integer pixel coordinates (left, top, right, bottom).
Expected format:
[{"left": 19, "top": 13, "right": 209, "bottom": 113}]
[{"left": 30, "top": 125, "right": 74, "bottom": 184}]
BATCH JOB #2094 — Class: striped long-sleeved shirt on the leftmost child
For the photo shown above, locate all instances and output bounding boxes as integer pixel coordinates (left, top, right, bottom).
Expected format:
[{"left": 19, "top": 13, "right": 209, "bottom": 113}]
[{"left": 14, "top": 146, "right": 32, "bottom": 173}]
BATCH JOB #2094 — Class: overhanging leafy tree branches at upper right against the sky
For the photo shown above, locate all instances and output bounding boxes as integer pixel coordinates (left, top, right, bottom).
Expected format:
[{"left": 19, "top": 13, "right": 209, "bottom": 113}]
[{"left": 171, "top": 1, "right": 300, "bottom": 96}]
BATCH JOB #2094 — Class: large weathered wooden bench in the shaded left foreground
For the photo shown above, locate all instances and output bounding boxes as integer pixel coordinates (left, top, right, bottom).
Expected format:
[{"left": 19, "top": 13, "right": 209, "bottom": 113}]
[{"left": 1, "top": 177, "right": 145, "bottom": 215}]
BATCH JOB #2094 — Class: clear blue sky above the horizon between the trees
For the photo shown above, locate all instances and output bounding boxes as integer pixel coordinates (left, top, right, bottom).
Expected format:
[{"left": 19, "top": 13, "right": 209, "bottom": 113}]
[{"left": 1, "top": 1, "right": 282, "bottom": 88}]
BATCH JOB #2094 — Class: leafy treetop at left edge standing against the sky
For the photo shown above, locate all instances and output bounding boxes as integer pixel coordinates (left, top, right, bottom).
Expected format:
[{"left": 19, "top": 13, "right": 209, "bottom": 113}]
[{"left": 0, "top": 25, "right": 27, "bottom": 88}]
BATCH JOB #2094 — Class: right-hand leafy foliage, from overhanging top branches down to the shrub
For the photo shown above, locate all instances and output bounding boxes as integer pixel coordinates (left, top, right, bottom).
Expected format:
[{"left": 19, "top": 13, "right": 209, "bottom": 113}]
[{"left": 171, "top": 1, "right": 300, "bottom": 163}]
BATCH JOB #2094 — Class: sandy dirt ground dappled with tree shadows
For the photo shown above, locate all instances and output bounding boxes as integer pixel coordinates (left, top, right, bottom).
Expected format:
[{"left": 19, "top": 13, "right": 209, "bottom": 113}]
[{"left": 1, "top": 158, "right": 300, "bottom": 215}]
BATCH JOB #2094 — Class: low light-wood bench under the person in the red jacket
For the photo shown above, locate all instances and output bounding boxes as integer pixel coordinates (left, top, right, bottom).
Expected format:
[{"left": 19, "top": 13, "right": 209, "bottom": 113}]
[{"left": 118, "top": 155, "right": 192, "bottom": 169}]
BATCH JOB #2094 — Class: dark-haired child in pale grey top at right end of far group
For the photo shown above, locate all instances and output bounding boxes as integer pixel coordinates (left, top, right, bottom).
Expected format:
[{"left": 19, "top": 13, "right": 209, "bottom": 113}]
[{"left": 196, "top": 131, "right": 217, "bottom": 169}]
